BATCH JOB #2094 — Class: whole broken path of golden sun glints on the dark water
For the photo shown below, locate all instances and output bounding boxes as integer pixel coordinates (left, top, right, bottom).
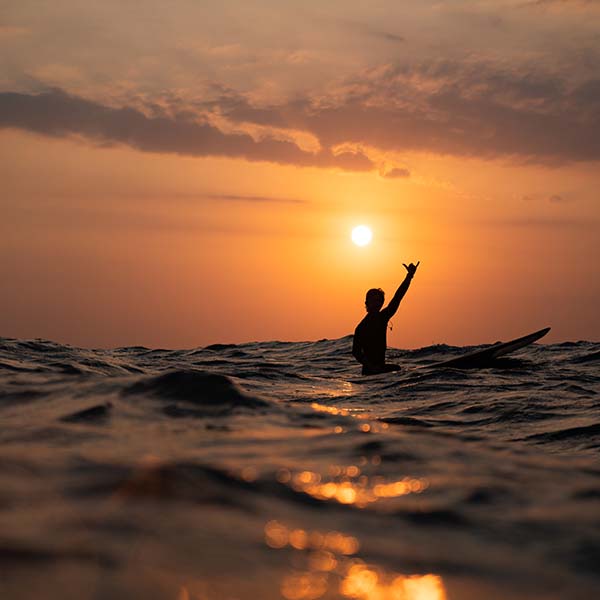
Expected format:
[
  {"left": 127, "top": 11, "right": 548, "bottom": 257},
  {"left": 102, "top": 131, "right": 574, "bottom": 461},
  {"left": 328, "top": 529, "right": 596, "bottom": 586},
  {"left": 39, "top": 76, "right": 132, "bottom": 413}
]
[{"left": 258, "top": 402, "right": 447, "bottom": 600}]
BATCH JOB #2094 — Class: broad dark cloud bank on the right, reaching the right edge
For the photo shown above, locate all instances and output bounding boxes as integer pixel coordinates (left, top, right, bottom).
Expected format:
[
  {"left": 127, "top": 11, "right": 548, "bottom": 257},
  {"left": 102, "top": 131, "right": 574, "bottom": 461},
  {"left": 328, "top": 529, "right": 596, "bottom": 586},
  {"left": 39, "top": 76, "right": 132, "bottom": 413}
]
[{"left": 219, "top": 61, "right": 600, "bottom": 164}]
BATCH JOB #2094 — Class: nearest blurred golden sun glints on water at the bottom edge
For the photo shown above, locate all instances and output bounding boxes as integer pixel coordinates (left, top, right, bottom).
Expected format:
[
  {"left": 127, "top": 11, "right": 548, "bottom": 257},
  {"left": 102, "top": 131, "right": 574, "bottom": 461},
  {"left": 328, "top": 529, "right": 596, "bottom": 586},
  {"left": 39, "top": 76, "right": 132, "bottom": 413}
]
[{"left": 264, "top": 521, "right": 447, "bottom": 600}]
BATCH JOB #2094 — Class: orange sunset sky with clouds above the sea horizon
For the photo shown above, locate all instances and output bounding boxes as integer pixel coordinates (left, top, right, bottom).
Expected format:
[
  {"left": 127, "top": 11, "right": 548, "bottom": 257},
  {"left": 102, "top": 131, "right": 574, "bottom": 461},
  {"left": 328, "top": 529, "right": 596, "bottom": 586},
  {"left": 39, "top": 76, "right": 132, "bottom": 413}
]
[{"left": 0, "top": 0, "right": 600, "bottom": 348}]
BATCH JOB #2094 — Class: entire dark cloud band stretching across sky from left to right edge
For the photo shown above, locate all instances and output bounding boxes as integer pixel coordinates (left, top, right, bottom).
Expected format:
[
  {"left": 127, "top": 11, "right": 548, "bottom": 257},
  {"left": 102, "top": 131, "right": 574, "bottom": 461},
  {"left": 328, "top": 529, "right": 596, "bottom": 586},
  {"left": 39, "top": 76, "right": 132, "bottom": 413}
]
[{"left": 0, "top": 60, "right": 600, "bottom": 169}]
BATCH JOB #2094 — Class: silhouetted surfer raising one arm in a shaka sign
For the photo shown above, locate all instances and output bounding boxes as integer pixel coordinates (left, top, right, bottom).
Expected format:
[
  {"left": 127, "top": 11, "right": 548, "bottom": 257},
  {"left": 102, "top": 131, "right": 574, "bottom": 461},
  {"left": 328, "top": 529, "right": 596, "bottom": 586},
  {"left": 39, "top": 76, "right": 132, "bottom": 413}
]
[{"left": 352, "top": 261, "right": 420, "bottom": 375}]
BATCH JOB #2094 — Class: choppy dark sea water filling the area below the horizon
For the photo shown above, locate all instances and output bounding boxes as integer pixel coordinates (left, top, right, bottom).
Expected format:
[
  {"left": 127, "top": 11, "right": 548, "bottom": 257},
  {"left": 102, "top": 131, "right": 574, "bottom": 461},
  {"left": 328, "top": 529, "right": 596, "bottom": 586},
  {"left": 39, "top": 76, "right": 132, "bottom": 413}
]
[{"left": 0, "top": 337, "right": 600, "bottom": 600}]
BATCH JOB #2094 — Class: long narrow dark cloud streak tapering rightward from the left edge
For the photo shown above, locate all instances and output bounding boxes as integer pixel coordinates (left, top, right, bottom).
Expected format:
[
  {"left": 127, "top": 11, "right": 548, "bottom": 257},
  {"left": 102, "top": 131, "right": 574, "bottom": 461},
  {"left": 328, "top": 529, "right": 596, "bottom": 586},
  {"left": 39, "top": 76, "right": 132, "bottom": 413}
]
[{"left": 0, "top": 90, "right": 374, "bottom": 171}]
